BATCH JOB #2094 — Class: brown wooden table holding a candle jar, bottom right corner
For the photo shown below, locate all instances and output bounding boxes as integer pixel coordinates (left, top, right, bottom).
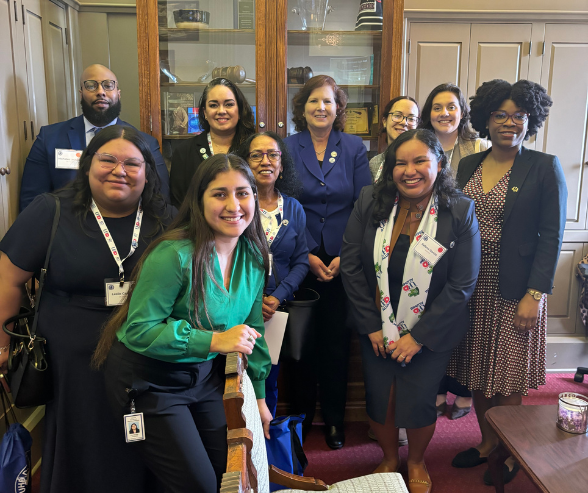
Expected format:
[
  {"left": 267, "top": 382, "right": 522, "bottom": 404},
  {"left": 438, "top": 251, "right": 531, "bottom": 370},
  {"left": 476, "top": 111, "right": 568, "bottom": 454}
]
[{"left": 486, "top": 406, "right": 588, "bottom": 493}]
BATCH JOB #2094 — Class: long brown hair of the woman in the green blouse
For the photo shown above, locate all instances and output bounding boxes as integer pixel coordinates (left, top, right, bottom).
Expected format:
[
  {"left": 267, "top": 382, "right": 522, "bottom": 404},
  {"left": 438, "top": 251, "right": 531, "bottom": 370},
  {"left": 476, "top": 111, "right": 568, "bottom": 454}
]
[{"left": 92, "top": 154, "right": 269, "bottom": 368}]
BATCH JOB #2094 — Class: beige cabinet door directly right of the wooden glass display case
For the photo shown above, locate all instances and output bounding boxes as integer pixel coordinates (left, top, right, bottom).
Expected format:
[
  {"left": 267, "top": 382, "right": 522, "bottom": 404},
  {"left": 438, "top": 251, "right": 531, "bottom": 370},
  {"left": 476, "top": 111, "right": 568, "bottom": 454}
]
[{"left": 407, "top": 22, "right": 470, "bottom": 106}]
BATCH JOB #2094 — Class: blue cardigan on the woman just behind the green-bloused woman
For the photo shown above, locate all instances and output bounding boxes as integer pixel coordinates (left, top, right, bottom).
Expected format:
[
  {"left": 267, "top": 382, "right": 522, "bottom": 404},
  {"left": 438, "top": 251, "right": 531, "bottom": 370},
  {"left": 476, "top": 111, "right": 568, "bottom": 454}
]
[{"left": 265, "top": 194, "right": 309, "bottom": 303}]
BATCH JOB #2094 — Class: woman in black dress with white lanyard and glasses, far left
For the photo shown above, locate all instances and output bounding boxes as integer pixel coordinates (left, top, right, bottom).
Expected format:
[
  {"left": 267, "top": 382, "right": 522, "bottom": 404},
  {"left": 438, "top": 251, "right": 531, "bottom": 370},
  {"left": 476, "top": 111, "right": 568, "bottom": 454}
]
[{"left": 0, "top": 125, "right": 171, "bottom": 493}]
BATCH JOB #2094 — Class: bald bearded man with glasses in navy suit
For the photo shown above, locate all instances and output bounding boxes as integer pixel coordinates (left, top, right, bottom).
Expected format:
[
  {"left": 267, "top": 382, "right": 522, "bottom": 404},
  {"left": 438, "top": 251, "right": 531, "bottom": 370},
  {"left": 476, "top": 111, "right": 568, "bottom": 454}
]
[{"left": 20, "top": 65, "right": 169, "bottom": 211}]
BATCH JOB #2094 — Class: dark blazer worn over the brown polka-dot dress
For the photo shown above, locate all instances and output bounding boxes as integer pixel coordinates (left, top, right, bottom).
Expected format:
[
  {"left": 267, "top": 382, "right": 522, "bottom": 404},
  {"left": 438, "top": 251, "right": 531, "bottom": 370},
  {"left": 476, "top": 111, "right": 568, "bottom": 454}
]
[{"left": 457, "top": 147, "right": 568, "bottom": 300}]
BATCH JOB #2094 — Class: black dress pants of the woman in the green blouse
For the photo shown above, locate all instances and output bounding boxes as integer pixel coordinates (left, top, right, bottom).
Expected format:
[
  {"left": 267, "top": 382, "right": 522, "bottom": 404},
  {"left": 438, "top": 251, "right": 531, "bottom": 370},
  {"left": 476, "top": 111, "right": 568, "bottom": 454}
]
[{"left": 106, "top": 342, "right": 227, "bottom": 493}]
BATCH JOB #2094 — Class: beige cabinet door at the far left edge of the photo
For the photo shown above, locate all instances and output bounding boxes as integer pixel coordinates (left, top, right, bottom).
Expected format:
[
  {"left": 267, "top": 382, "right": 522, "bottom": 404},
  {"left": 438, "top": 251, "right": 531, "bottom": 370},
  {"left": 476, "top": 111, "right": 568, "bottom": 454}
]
[{"left": 0, "top": 0, "right": 30, "bottom": 238}]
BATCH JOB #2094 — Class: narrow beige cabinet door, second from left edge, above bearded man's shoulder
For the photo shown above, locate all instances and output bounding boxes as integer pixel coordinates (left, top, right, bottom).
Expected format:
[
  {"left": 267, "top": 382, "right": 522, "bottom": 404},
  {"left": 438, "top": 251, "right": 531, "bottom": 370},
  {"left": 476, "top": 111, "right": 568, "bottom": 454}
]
[{"left": 22, "top": 0, "right": 49, "bottom": 144}]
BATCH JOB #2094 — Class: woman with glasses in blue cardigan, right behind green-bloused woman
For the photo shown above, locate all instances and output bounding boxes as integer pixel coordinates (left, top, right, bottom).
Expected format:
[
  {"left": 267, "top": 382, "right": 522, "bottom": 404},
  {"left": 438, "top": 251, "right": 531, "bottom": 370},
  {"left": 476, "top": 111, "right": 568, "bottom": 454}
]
[{"left": 239, "top": 132, "right": 308, "bottom": 417}]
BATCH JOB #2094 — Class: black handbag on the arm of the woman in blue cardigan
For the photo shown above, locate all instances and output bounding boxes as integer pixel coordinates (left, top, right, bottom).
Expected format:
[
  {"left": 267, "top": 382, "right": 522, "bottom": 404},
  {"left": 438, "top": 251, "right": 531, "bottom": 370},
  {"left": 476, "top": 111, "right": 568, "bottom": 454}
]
[{"left": 273, "top": 266, "right": 320, "bottom": 361}]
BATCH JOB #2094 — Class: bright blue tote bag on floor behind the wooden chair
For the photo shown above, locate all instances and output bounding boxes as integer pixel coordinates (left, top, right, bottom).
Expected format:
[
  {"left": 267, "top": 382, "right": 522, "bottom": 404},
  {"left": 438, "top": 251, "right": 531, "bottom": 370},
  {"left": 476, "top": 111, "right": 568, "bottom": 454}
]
[{"left": 265, "top": 414, "right": 308, "bottom": 491}]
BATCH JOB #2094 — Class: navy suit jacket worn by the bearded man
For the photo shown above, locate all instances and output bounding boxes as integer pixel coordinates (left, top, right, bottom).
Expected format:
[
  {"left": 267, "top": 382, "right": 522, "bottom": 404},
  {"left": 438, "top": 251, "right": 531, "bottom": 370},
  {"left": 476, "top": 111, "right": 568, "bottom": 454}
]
[{"left": 20, "top": 115, "right": 169, "bottom": 211}]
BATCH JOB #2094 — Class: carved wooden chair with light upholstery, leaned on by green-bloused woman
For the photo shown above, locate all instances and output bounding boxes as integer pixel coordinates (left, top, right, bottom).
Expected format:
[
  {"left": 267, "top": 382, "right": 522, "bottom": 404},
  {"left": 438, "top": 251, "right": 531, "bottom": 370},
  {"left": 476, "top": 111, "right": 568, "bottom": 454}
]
[{"left": 220, "top": 353, "right": 408, "bottom": 493}]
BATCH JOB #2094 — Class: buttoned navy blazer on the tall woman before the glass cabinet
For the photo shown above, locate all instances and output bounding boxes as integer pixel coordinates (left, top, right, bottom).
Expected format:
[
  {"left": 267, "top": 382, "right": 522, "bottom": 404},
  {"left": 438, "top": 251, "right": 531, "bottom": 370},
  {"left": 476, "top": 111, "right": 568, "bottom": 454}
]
[{"left": 284, "top": 130, "right": 372, "bottom": 256}]
